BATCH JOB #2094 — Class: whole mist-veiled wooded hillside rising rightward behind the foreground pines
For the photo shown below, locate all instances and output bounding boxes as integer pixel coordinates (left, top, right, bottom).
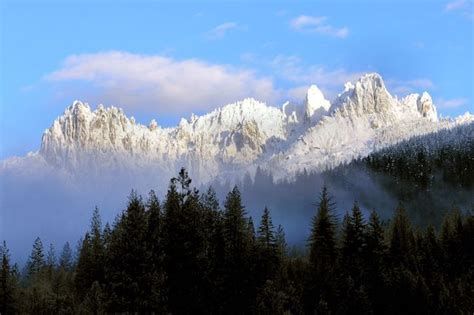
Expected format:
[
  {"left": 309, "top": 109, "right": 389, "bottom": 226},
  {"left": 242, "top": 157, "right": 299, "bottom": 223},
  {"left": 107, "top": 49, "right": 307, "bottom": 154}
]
[{"left": 212, "top": 123, "right": 474, "bottom": 238}]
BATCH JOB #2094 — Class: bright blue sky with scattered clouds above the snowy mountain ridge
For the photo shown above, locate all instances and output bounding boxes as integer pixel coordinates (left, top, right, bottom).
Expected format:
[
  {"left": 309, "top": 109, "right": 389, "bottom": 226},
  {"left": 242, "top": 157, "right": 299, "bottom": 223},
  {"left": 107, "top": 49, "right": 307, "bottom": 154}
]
[{"left": 0, "top": 0, "right": 474, "bottom": 158}]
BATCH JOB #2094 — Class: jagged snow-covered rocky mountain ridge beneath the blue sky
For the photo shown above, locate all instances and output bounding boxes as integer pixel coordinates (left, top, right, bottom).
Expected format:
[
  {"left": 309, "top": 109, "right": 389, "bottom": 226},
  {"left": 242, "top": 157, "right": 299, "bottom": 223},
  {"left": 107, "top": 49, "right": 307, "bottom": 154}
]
[{"left": 0, "top": 73, "right": 474, "bottom": 183}]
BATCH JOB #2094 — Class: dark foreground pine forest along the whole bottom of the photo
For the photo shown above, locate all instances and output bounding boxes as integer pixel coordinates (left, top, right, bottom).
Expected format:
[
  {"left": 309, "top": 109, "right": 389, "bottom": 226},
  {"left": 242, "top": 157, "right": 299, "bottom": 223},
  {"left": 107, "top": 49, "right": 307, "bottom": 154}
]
[{"left": 0, "top": 169, "right": 474, "bottom": 314}]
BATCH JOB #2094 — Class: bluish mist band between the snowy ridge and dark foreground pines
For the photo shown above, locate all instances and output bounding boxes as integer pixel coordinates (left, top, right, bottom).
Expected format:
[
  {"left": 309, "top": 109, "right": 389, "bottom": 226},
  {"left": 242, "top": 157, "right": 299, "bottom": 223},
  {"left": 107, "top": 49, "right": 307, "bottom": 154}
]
[{"left": 0, "top": 154, "right": 474, "bottom": 265}]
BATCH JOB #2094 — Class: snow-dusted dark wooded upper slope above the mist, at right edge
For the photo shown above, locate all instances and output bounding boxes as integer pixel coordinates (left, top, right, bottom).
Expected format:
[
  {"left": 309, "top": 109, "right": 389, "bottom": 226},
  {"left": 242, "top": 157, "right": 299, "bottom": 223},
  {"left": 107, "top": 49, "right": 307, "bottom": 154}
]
[{"left": 365, "top": 123, "right": 474, "bottom": 189}]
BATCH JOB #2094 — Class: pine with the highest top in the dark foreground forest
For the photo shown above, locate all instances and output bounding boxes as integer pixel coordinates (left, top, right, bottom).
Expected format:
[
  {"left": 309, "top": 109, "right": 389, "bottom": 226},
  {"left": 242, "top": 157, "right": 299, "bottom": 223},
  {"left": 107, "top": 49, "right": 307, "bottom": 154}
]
[{"left": 163, "top": 169, "right": 209, "bottom": 313}]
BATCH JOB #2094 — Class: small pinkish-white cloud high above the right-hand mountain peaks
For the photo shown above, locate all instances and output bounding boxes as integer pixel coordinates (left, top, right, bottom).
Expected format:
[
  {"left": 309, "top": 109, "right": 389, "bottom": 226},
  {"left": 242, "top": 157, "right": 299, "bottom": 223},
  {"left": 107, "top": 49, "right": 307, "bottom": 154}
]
[{"left": 290, "top": 15, "right": 349, "bottom": 38}]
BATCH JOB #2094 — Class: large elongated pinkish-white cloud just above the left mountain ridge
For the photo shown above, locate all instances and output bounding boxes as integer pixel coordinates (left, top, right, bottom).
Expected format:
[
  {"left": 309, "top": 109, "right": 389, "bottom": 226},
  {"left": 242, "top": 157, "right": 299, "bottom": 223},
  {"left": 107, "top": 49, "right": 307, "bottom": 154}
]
[{"left": 44, "top": 51, "right": 280, "bottom": 113}]
